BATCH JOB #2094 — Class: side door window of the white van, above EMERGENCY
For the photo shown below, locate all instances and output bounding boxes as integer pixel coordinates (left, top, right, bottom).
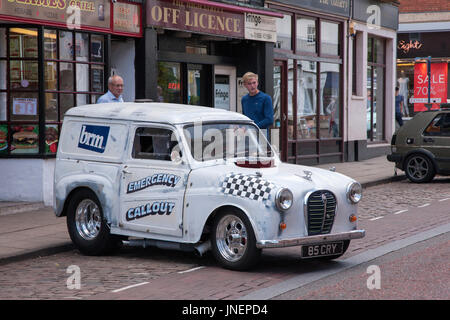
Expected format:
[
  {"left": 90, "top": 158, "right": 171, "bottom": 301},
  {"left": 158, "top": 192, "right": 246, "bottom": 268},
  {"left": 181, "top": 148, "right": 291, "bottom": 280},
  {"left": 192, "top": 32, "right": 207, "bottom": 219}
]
[{"left": 132, "top": 128, "right": 178, "bottom": 161}]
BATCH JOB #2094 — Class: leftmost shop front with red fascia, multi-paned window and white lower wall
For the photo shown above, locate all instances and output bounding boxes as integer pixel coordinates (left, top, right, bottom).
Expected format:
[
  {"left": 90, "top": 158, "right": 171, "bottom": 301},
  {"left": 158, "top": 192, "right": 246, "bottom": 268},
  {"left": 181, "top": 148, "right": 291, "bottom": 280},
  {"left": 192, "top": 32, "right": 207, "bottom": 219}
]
[{"left": 0, "top": 0, "right": 142, "bottom": 205}]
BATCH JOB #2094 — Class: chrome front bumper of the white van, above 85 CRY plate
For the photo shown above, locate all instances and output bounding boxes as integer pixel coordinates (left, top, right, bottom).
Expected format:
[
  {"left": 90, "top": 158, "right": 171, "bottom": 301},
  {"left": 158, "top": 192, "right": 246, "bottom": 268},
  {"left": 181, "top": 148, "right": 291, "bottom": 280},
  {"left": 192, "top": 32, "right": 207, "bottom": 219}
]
[{"left": 256, "top": 230, "right": 366, "bottom": 249}]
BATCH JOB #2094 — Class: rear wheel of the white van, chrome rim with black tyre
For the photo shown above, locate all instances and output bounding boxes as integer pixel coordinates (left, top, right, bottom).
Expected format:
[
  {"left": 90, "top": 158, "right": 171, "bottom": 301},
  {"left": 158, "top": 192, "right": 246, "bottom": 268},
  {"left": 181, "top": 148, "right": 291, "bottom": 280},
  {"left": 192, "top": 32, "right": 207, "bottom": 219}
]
[{"left": 67, "top": 190, "right": 121, "bottom": 255}]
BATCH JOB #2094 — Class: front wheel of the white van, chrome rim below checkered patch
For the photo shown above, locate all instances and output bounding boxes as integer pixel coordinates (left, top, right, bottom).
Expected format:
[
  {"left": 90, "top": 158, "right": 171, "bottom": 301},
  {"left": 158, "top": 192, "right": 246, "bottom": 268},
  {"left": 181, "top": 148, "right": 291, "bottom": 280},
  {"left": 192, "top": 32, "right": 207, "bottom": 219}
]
[{"left": 211, "top": 211, "right": 261, "bottom": 270}]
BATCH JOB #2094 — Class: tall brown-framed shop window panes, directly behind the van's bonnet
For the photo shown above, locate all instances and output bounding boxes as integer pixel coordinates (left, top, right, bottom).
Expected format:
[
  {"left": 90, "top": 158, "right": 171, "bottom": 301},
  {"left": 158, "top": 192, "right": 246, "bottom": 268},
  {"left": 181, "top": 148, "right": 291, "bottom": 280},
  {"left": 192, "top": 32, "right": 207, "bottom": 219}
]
[{"left": 274, "top": 12, "right": 344, "bottom": 164}]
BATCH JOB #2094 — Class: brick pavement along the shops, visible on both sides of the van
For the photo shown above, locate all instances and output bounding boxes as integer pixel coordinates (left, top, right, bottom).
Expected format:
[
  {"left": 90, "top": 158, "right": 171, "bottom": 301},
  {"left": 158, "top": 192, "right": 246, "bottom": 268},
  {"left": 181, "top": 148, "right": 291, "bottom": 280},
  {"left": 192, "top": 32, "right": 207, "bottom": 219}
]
[{"left": 0, "top": 156, "right": 405, "bottom": 265}]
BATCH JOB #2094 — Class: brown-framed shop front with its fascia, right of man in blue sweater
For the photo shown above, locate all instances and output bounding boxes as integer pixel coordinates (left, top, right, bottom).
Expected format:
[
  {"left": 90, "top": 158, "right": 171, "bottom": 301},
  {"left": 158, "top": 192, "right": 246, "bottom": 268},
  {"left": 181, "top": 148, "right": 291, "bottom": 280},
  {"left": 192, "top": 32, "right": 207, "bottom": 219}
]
[{"left": 266, "top": 0, "right": 350, "bottom": 165}]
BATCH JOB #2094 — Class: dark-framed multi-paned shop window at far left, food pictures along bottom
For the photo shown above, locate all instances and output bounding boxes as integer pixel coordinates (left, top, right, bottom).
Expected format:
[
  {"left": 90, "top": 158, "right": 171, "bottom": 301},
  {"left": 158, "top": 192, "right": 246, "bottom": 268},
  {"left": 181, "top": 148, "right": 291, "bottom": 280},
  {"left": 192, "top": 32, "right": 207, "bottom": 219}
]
[{"left": 0, "top": 27, "right": 105, "bottom": 155}]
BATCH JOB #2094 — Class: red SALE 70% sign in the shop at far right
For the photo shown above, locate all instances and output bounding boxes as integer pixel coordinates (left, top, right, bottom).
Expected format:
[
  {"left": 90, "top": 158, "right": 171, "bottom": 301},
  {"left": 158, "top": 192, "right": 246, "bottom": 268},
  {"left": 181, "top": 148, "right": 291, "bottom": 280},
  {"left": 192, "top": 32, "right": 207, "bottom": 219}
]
[{"left": 412, "top": 63, "right": 448, "bottom": 112}]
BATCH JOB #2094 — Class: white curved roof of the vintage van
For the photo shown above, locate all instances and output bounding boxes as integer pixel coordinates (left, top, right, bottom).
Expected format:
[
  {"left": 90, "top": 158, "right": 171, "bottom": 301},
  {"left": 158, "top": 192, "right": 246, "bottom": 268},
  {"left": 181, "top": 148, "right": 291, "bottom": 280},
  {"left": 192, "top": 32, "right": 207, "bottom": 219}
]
[{"left": 65, "top": 102, "right": 251, "bottom": 124}]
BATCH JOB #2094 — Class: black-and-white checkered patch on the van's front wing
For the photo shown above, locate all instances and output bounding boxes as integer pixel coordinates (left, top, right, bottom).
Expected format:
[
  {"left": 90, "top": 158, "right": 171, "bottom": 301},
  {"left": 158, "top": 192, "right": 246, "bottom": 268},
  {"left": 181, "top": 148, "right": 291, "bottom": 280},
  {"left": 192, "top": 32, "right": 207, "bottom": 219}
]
[{"left": 222, "top": 173, "right": 275, "bottom": 200}]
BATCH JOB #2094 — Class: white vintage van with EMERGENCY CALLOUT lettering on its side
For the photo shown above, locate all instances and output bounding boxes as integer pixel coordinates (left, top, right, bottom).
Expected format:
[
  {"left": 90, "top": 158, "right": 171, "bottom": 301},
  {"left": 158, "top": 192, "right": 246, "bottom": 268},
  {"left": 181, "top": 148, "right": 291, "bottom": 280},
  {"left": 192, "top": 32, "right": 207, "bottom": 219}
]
[{"left": 54, "top": 103, "right": 365, "bottom": 269}]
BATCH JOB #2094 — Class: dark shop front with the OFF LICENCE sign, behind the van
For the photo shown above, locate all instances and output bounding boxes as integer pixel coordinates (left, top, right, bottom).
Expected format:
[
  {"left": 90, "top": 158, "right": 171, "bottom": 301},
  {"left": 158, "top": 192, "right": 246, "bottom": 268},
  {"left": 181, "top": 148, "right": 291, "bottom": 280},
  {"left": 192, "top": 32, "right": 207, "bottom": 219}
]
[{"left": 136, "top": 0, "right": 282, "bottom": 112}]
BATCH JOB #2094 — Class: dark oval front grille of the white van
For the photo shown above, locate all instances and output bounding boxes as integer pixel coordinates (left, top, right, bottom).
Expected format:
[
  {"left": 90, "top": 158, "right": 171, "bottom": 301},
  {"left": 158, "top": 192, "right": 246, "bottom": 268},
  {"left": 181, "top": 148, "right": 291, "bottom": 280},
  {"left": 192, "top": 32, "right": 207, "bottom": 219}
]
[{"left": 306, "top": 190, "right": 336, "bottom": 236}]
